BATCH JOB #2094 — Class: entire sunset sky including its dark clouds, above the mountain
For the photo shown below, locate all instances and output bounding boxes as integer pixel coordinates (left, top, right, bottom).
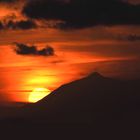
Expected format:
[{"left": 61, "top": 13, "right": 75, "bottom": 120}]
[{"left": 0, "top": 0, "right": 140, "bottom": 103}]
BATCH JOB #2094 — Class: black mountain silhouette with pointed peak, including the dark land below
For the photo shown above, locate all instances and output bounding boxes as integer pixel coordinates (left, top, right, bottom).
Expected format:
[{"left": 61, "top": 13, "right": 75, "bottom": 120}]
[{"left": 0, "top": 72, "right": 140, "bottom": 140}]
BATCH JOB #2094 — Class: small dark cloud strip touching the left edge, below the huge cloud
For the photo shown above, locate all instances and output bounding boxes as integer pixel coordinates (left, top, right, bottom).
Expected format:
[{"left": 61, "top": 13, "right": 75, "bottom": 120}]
[{"left": 0, "top": 20, "right": 37, "bottom": 30}]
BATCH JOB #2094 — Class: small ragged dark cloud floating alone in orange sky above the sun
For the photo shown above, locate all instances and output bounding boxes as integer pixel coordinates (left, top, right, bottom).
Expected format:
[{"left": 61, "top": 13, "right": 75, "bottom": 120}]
[{"left": 14, "top": 43, "right": 54, "bottom": 56}]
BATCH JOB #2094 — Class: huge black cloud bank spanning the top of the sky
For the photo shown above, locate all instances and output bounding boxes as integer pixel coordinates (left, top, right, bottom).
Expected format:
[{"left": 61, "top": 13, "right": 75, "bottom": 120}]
[{"left": 22, "top": 0, "right": 140, "bottom": 28}]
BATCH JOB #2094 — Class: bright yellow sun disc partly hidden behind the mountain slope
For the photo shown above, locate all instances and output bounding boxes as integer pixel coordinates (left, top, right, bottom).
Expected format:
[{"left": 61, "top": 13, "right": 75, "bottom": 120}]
[{"left": 28, "top": 88, "right": 51, "bottom": 103}]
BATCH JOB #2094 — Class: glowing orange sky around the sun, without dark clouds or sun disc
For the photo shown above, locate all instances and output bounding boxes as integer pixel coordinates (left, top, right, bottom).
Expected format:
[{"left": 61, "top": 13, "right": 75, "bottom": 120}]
[{"left": 0, "top": 1, "right": 140, "bottom": 102}]
